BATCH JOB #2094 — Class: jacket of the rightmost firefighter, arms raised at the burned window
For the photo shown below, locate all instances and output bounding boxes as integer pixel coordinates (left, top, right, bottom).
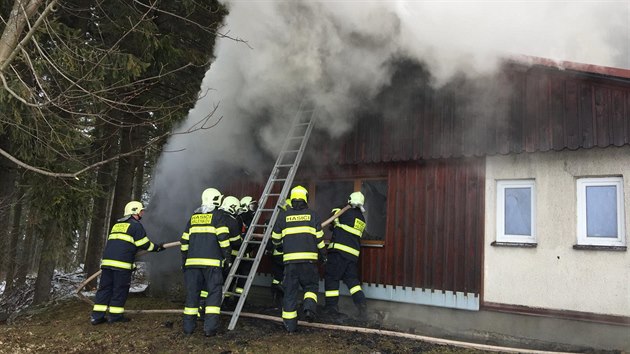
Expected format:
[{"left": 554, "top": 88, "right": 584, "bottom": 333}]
[{"left": 328, "top": 208, "right": 365, "bottom": 260}]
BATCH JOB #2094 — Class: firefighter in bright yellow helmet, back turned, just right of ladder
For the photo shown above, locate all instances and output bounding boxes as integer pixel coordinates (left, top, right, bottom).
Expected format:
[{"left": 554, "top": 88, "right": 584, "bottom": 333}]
[{"left": 272, "top": 186, "right": 325, "bottom": 333}]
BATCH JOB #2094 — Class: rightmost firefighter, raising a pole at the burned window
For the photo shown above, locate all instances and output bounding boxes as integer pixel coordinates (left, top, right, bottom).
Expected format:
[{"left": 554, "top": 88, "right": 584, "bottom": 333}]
[{"left": 324, "top": 192, "right": 367, "bottom": 319}]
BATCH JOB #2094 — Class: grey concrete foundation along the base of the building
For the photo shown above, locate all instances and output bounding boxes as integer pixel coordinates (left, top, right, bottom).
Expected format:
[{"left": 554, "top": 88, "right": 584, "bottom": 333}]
[{"left": 247, "top": 287, "right": 630, "bottom": 352}]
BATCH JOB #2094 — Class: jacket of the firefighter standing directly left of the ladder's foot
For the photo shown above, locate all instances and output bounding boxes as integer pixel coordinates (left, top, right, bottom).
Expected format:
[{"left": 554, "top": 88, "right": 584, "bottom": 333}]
[{"left": 180, "top": 208, "right": 230, "bottom": 268}]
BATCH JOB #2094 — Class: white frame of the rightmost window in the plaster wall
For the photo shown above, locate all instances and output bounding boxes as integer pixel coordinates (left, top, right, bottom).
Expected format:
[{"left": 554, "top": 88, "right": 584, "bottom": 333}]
[{"left": 576, "top": 177, "right": 626, "bottom": 247}]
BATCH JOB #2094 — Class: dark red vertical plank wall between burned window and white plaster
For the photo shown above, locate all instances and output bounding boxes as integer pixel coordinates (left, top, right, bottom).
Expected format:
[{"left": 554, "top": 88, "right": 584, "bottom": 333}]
[{"left": 361, "top": 158, "right": 485, "bottom": 294}]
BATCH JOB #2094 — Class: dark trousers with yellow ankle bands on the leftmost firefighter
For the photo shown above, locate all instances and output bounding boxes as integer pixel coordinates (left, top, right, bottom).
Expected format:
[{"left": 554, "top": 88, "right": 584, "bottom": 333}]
[{"left": 92, "top": 268, "right": 131, "bottom": 321}]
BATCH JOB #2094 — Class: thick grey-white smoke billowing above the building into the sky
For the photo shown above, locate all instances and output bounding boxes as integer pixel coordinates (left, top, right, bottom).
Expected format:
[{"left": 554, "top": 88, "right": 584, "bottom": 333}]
[{"left": 147, "top": 0, "right": 630, "bottom": 276}]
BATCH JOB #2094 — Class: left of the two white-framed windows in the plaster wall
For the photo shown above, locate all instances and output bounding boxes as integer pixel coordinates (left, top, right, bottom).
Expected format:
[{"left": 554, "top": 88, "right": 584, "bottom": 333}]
[{"left": 497, "top": 180, "right": 536, "bottom": 243}]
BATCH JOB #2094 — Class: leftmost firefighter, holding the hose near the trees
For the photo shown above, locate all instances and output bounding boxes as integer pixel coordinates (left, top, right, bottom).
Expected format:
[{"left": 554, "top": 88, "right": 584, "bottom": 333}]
[{"left": 90, "top": 201, "right": 164, "bottom": 325}]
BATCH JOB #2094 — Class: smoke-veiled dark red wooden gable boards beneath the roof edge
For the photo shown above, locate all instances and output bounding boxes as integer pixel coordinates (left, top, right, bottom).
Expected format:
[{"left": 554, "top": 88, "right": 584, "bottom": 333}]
[{"left": 339, "top": 65, "right": 630, "bottom": 164}]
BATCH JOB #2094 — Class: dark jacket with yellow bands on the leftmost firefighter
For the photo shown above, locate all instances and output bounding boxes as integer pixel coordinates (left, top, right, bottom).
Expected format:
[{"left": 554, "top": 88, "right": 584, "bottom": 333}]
[{"left": 101, "top": 216, "right": 156, "bottom": 270}]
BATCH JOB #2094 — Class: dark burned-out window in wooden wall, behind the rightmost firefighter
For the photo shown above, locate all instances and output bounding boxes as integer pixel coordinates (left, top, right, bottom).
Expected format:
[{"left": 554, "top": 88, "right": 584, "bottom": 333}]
[{"left": 313, "top": 179, "right": 387, "bottom": 245}]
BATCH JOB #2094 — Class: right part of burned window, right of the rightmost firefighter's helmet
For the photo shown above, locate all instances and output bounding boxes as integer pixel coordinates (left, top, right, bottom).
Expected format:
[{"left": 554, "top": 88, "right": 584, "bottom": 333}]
[{"left": 361, "top": 179, "right": 387, "bottom": 243}]
